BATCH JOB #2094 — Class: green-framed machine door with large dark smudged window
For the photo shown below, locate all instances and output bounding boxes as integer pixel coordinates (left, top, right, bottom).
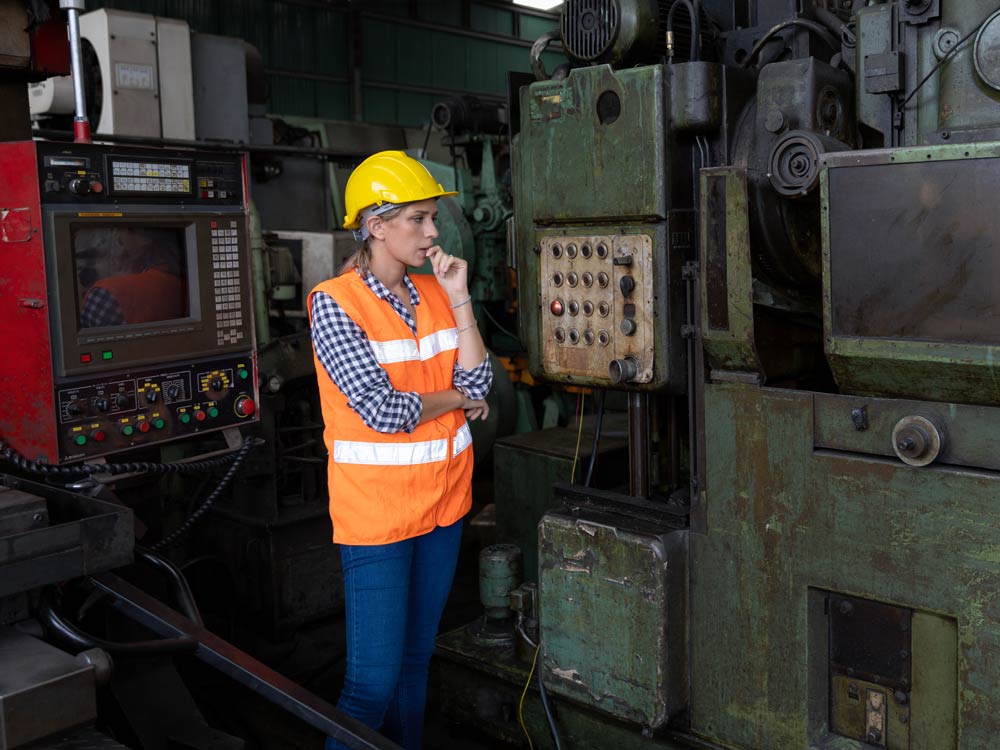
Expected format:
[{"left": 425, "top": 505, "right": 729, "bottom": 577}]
[{"left": 820, "top": 143, "right": 1000, "bottom": 405}]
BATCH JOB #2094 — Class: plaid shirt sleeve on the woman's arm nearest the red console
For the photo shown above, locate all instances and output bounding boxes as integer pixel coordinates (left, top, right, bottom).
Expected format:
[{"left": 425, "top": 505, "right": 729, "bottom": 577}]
[{"left": 312, "top": 292, "right": 424, "bottom": 433}]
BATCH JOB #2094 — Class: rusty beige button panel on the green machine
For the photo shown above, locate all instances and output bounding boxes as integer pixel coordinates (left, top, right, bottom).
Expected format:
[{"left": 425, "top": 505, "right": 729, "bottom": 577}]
[{"left": 539, "top": 234, "right": 656, "bottom": 385}]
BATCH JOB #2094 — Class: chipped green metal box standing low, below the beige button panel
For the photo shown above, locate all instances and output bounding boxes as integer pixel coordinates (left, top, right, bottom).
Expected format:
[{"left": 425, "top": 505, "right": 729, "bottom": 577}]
[{"left": 539, "top": 510, "right": 688, "bottom": 728}]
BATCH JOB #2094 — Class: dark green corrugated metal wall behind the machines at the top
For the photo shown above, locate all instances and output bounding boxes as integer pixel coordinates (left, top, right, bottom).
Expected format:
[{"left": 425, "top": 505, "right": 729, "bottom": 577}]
[{"left": 87, "top": 0, "right": 562, "bottom": 125}]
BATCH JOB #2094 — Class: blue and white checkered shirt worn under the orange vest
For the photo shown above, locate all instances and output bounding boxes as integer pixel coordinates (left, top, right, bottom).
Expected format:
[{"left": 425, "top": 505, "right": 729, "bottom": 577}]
[{"left": 312, "top": 272, "right": 493, "bottom": 433}]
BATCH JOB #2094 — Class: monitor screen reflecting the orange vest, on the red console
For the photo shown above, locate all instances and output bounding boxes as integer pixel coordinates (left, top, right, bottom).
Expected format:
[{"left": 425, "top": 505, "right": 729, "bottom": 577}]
[{"left": 70, "top": 224, "right": 191, "bottom": 329}]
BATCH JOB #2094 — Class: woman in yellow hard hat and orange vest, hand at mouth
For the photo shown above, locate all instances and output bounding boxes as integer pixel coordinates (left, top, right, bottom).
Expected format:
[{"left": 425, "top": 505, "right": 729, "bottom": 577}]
[{"left": 309, "top": 151, "right": 493, "bottom": 749}]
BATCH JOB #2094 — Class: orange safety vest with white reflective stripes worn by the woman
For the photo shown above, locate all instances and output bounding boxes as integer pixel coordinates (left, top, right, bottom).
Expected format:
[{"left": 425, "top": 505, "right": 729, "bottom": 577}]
[{"left": 309, "top": 271, "right": 473, "bottom": 545}]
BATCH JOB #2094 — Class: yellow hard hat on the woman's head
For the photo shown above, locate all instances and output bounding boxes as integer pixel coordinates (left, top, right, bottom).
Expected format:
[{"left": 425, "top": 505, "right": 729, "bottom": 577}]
[{"left": 344, "top": 151, "right": 458, "bottom": 229}]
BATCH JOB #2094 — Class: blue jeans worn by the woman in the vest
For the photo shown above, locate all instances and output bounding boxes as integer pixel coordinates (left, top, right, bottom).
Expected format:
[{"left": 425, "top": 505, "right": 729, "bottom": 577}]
[{"left": 326, "top": 521, "right": 462, "bottom": 750}]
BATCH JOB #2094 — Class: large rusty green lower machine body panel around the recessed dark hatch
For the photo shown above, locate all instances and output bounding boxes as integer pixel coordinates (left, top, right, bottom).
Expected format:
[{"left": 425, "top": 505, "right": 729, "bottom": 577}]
[{"left": 690, "top": 384, "right": 1000, "bottom": 750}]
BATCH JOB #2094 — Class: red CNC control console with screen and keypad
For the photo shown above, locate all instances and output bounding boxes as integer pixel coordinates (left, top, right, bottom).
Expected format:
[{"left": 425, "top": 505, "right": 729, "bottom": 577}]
[{"left": 0, "top": 142, "right": 258, "bottom": 463}]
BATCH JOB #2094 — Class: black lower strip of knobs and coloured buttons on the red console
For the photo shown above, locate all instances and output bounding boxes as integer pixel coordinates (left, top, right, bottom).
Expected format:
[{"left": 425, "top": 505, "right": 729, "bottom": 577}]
[{"left": 56, "top": 356, "right": 257, "bottom": 461}]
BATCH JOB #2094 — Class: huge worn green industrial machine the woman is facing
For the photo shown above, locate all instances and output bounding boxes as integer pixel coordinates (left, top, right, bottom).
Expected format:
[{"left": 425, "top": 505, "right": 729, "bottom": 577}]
[{"left": 435, "top": 0, "right": 1000, "bottom": 750}]
